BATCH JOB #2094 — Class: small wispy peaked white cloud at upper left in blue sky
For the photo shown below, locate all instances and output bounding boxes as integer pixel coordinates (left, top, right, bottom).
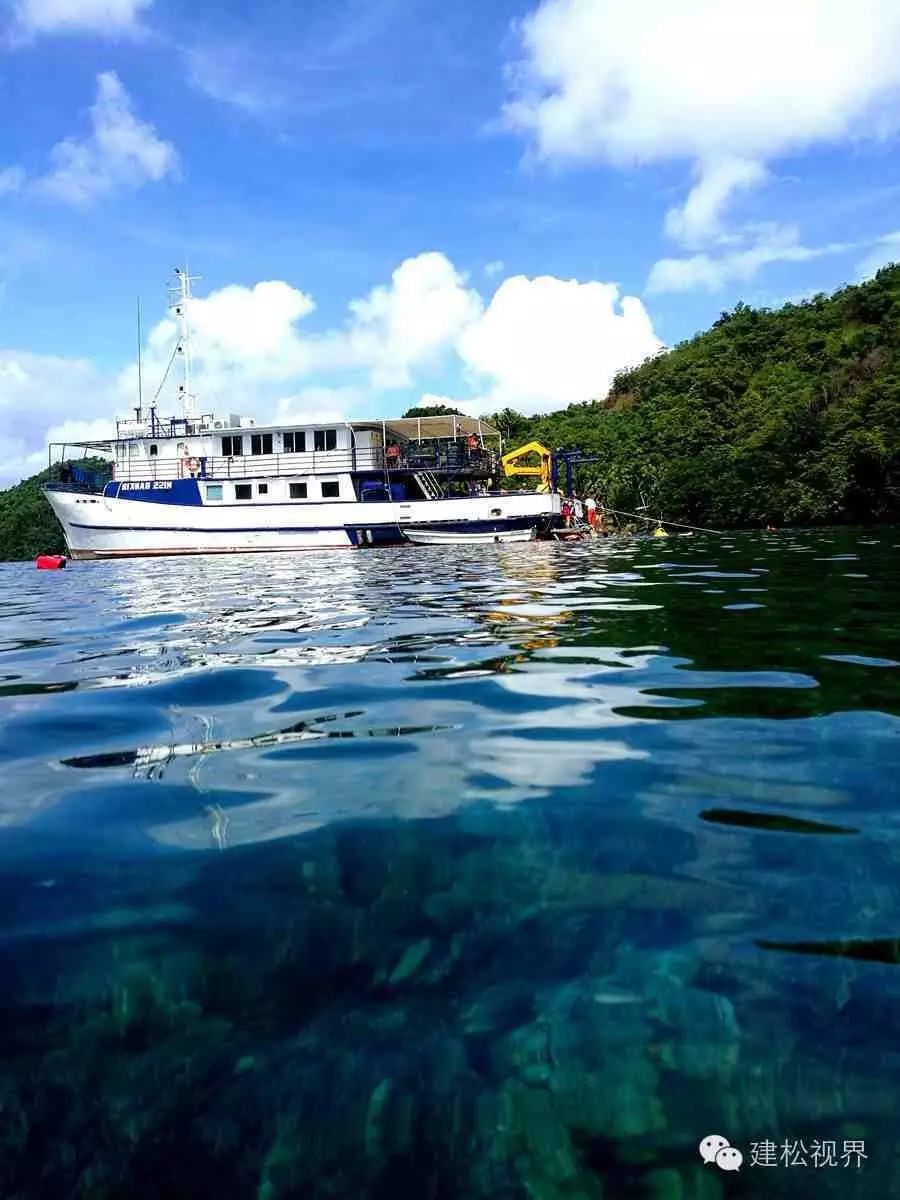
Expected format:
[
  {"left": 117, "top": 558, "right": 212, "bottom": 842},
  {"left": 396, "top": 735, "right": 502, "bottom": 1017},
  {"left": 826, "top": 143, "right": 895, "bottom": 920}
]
[{"left": 34, "top": 71, "right": 178, "bottom": 205}]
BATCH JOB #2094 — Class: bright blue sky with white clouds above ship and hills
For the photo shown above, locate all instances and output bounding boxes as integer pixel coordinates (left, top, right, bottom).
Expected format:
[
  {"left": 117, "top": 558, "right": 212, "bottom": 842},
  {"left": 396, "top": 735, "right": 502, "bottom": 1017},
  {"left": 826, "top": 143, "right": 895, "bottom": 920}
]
[{"left": 0, "top": 0, "right": 900, "bottom": 479}]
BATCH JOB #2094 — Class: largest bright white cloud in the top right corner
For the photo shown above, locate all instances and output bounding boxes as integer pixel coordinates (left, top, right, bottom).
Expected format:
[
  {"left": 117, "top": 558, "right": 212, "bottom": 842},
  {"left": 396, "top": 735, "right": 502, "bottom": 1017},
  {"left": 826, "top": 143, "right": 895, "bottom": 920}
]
[{"left": 504, "top": 0, "right": 900, "bottom": 240}]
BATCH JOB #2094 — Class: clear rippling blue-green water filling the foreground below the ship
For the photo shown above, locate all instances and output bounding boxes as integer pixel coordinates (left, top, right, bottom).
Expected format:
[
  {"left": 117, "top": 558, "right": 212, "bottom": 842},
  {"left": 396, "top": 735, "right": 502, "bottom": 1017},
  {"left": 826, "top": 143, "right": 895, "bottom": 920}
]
[{"left": 0, "top": 530, "right": 900, "bottom": 1200}]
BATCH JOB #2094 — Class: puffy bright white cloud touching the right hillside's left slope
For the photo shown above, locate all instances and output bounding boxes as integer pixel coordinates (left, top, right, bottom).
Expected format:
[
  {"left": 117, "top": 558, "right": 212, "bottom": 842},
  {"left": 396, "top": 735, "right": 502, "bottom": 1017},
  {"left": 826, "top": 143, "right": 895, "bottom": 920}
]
[{"left": 458, "top": 275, "right": 661, "bottom": 412}]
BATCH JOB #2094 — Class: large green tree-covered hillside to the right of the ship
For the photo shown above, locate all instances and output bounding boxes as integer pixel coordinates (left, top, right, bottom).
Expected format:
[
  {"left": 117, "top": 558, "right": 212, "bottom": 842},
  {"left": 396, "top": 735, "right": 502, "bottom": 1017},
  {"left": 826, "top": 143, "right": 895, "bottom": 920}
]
[{"left": 493, "top": 265, "right": 900, "bottom": 527}]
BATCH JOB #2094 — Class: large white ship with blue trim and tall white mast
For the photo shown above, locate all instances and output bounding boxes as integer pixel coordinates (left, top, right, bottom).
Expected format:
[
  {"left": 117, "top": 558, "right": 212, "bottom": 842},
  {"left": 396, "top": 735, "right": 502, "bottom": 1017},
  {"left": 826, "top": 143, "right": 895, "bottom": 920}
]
[{"left": 44, "top": 272, "right": 559, "bottom": 559}]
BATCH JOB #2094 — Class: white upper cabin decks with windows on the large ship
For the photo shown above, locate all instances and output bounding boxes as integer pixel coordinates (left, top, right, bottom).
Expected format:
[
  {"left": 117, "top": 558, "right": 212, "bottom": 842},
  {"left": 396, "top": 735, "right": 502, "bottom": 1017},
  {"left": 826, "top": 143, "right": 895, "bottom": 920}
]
[{"left": 50, "top": 409, "right": 502, "bottom": 504}]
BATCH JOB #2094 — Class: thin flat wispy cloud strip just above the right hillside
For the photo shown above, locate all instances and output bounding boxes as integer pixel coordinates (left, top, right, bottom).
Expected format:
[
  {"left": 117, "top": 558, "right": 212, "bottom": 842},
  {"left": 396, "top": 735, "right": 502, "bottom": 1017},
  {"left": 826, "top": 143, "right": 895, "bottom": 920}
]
[{"left": 647, "top": 227, "right": 853, "bottom": 293}]
